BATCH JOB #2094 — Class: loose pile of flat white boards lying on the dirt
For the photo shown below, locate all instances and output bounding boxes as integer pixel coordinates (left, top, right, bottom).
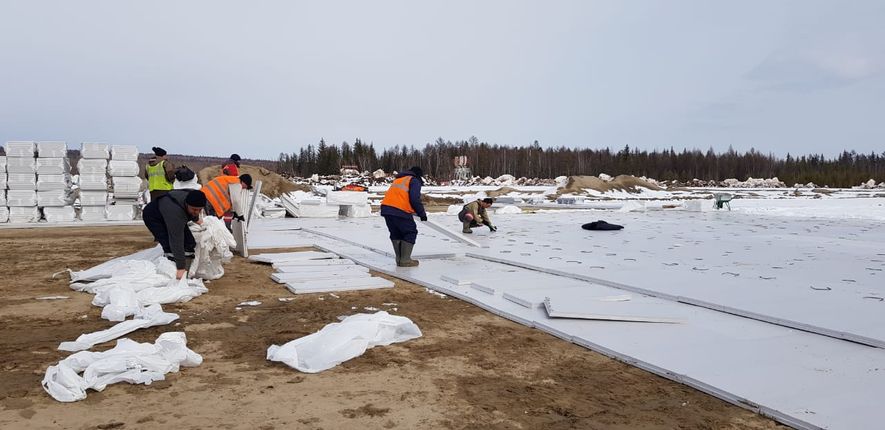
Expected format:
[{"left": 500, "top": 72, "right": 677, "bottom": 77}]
[{"left": 249, "top": 251, "right": 393, "bottom": 294}]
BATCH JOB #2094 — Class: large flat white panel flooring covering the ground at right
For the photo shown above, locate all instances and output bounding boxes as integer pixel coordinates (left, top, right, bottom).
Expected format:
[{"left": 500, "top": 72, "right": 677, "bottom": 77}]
[{"left": 245, "top": 217, "right": 885, "bottom": 428}]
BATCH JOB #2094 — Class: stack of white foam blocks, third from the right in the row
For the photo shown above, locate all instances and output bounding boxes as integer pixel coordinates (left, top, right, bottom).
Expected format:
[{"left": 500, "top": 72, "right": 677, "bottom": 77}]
[{"left": 37, "top": 142, "right": 76, "bottom": 222}]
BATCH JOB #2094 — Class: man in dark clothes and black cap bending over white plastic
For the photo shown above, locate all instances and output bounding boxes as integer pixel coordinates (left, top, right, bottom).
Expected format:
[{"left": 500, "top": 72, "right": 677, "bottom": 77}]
[{"left": 142, "top": 190, "right": 206, "bottom": 279}]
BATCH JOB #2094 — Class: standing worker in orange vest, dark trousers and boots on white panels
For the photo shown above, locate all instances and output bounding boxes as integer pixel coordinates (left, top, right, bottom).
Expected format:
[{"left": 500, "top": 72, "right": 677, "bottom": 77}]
[{"left": 381, "top": 167, "right": 427, "bottom": 267}]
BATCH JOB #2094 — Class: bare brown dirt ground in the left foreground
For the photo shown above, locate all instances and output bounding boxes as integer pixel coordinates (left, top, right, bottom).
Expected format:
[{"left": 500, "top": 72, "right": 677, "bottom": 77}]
[{"left": 0, "top": 227, "right": 778, "bottom": 429}]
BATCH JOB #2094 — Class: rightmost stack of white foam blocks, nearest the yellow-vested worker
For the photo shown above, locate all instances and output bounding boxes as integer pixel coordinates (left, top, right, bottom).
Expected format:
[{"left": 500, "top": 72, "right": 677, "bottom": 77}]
[{"left": 106, "top": 145, "right": 142, "bottom": 221}]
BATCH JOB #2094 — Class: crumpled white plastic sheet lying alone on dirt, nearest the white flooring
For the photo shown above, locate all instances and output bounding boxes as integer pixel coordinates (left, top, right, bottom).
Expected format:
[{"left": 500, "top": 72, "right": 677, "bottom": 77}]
[{"left": 267, "top": 311, "right": 421, "bottom": 373}]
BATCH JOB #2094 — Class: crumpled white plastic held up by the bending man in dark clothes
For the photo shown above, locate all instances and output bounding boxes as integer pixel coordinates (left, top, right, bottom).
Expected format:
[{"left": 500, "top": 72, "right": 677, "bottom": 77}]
[{"left": 188, "top": 216, "right": 237, "bottom": 281}]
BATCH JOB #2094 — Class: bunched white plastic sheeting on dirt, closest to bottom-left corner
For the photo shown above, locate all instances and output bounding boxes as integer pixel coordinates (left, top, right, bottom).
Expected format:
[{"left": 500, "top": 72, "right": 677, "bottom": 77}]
[{"left": 43, "top": 332, "right": 203, "bottom": 402}]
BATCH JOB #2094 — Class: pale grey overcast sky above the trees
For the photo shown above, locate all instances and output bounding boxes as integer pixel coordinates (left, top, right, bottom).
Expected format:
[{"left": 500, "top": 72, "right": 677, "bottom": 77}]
[{"left": 0, "top": 0, "right": 885, "bottom": 158}]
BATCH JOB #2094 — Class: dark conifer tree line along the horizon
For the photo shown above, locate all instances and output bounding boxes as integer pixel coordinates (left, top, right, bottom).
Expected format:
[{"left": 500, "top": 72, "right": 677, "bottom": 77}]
[{"left": 276, "top": 137, "right": 885, "bottom": 187}]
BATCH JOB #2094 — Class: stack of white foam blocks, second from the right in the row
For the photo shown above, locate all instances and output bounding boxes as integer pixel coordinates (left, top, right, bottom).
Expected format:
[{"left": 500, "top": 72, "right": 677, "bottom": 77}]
[{"left": 77, "top": 142, "right": 110, "bottom": 222}]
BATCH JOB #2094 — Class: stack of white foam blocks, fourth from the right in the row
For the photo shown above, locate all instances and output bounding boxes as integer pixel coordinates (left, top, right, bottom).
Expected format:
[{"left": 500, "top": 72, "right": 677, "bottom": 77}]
[{"left": 5, "top": 141, "right": 40, "bottom": 223}]
